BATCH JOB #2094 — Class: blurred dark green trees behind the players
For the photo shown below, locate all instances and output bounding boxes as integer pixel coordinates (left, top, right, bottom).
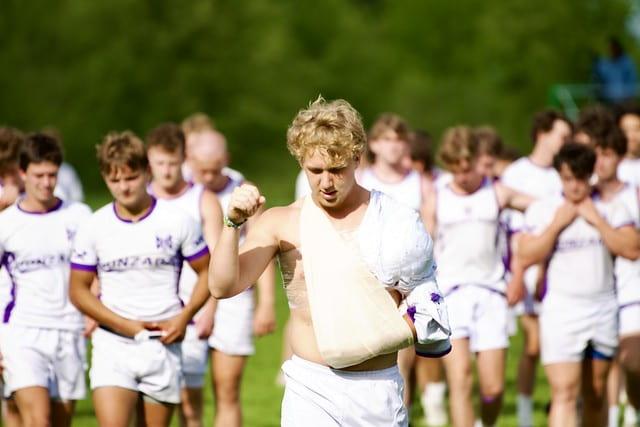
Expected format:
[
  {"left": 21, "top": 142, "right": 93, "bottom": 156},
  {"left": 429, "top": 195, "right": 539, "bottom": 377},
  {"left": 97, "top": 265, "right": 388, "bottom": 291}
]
[{"left": 0, "top": 0, "right": 635, "bottom": 201}]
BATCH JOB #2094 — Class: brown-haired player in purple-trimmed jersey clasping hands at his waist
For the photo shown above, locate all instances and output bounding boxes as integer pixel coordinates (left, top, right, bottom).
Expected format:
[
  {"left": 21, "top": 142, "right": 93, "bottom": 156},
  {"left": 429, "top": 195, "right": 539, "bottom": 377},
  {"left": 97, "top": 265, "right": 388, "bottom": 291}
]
[{"left": 70, "top": 132, "right": 209, "bottom": 427}]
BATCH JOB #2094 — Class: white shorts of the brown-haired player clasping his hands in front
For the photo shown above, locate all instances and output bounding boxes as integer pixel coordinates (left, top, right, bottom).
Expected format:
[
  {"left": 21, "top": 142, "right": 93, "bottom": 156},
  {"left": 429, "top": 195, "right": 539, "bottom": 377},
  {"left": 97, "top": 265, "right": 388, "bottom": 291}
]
[{"left": 89, "top": 328, "right": 182, "bottom": 403}]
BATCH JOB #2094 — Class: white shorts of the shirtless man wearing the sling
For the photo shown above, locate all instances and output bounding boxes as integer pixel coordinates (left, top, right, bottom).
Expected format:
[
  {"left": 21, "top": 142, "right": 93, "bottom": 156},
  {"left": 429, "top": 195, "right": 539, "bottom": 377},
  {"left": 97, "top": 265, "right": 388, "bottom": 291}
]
[{"left": 281, "top": 356, "right": 408, "bottom": 427}]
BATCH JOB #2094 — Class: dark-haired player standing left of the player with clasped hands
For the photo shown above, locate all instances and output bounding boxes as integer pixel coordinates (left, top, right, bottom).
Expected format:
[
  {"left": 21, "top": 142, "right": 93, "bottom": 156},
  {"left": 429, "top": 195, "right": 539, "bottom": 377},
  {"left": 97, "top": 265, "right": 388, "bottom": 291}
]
[{"left": 0, "top": 134, "right": 91, "bottom": 426}]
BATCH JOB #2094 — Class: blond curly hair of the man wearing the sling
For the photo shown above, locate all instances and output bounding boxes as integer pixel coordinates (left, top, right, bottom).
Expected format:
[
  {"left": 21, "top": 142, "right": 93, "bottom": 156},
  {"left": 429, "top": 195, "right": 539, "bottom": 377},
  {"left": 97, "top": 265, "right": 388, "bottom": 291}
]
[{"left": 287, "top": 96, "right": 367, "bottom": 167}]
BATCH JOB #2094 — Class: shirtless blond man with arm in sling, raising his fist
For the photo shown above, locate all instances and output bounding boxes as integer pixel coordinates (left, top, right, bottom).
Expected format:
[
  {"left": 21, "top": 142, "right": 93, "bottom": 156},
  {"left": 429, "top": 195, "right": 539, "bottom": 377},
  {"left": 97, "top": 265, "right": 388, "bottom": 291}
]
[{"left": 209, "top": 99, "right": 450, "bottom": 427}]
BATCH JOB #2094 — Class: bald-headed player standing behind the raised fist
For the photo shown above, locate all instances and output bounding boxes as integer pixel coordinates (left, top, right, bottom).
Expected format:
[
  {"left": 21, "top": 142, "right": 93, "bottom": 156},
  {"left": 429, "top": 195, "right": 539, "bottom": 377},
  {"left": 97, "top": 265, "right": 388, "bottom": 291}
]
[{"left": 189, "top": 125, "right": 275, "bottom": 427}]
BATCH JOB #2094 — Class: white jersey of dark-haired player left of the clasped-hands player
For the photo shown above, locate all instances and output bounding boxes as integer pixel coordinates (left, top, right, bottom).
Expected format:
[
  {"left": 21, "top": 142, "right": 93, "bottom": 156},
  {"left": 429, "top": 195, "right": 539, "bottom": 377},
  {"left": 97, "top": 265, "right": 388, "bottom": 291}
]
[{"left": 0, "top": 200, "right": 91, "bottom": 330}]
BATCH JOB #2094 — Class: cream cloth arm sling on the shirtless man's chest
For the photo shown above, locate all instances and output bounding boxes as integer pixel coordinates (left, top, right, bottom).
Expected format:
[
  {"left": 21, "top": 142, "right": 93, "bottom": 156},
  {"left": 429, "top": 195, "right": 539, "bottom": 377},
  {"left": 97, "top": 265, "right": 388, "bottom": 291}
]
[{"left": 300, "top": 197, "right": 413, "bottom": 368}]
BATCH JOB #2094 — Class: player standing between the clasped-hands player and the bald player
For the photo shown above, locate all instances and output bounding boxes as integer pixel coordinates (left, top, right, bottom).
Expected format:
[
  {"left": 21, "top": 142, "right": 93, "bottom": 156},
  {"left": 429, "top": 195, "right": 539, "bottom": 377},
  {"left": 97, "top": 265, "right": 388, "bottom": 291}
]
[{"left": 146, "top": 123, "right": 222, "bottom": 427}]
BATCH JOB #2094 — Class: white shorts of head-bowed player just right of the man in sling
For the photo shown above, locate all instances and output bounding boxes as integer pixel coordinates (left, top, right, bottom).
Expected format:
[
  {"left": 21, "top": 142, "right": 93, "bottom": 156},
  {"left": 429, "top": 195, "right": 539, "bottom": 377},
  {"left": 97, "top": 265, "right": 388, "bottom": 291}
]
[{"left": 445, "top": 285, "right": 509, "bottom": 352}]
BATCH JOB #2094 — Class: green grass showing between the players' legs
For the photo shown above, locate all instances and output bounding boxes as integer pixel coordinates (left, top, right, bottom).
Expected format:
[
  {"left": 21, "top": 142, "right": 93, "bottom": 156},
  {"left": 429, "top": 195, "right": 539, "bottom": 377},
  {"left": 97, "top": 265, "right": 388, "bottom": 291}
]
[{"left": 69, "top": 195, "right": 549, "bottom": 427}]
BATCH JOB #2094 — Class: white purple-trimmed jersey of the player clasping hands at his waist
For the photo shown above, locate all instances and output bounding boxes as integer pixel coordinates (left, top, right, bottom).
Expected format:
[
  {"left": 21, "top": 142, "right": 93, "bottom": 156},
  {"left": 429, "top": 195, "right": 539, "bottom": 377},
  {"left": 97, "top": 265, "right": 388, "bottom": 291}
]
[{"left": 71, "top": 199, "right": 208, "bottom": 321}]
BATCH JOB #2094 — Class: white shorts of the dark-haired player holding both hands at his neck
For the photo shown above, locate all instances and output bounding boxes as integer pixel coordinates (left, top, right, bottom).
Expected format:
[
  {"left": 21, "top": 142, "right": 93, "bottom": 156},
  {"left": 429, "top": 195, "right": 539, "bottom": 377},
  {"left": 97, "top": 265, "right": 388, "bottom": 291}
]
[{"left": 540, "top": 296, "right": 618, "bottom": 365}]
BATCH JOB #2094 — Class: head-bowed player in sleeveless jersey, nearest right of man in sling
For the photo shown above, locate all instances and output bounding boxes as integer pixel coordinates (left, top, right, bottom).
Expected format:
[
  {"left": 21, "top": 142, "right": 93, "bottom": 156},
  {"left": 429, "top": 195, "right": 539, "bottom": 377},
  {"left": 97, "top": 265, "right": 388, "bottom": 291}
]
[{"left": 424, "top": 126, "right": 532, "bottom": 427}]
